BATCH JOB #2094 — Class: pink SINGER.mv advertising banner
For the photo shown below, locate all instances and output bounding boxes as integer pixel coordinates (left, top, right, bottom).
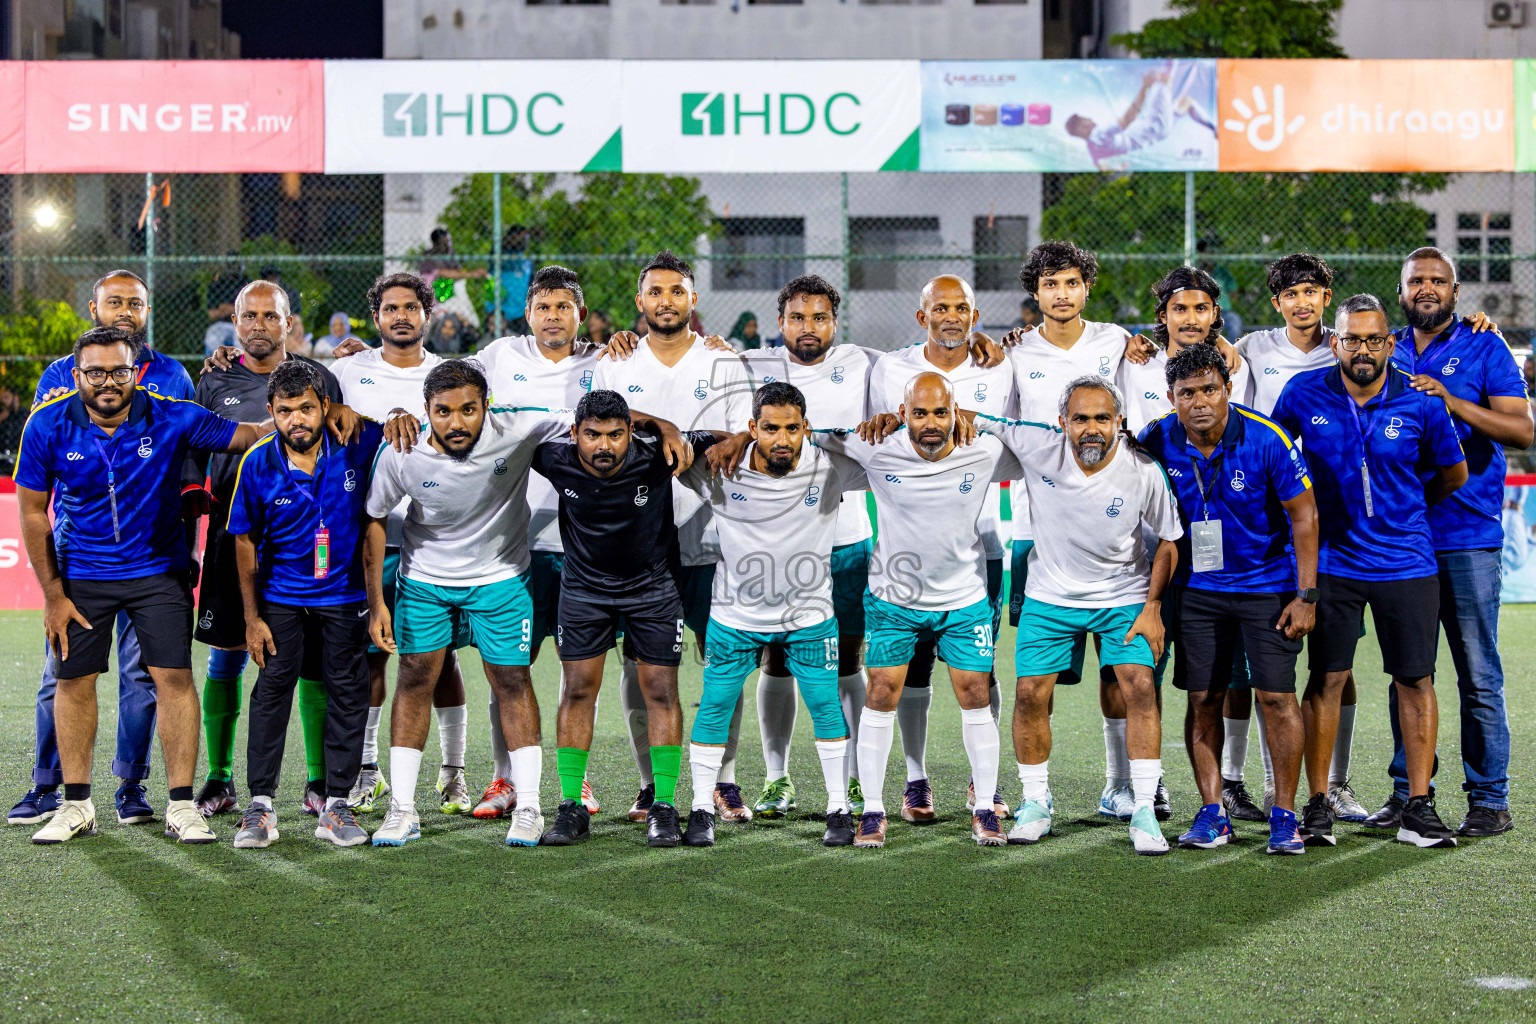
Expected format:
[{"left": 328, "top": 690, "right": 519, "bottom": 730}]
[{"left": 26, "top": 60, "right": 326, "bottom": 173}]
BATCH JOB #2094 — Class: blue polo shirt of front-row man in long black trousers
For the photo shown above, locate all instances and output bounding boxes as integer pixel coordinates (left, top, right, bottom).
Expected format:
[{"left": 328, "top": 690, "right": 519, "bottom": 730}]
[{"left": 227, "top": 419, "right": 384, "bottom": 608}]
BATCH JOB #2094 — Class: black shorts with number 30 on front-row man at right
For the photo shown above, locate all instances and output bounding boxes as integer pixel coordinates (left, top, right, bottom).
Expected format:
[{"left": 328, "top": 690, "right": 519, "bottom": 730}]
[{"left": 1307, "top": 573, "right": 1439, "bottom": 679}]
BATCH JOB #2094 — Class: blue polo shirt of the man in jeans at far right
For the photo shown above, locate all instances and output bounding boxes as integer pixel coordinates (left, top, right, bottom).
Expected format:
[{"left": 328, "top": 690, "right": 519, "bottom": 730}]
[{"left": 1393, "top": 319, "right": 1527, "bottom": 551}]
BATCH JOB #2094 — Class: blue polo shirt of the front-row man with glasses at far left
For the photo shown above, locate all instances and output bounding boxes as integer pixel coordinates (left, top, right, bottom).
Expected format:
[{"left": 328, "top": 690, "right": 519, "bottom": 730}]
[{"left": 15, "top": 387, "right": 238, "bottom": 580}]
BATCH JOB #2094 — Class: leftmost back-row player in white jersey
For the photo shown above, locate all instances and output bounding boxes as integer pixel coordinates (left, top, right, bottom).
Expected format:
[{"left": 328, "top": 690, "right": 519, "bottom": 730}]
[{"left": 330, "top": 273, "right": 472, "bottom": 814}]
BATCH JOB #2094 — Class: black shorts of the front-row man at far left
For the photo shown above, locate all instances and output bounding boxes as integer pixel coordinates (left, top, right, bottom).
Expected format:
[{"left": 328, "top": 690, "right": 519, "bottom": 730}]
[{"left": 54, "top": 573, "right": 195, "bottom": 679}]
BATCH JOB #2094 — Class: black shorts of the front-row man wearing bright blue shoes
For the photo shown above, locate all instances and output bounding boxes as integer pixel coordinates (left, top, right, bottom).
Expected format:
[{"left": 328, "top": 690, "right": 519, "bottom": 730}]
[{"left": 1174, "top": 586, "right": 1301, "bottom": 694}]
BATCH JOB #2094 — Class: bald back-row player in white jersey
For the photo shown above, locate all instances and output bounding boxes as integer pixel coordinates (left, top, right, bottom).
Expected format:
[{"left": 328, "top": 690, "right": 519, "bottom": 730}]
[{"left": 860, "top": 275, "right": 1015, "bottom": 824}]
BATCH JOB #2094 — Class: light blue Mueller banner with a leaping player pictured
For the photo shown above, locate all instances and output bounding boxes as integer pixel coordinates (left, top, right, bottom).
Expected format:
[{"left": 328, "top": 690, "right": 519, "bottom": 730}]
[{"left": 922, "top": 60, "right": 1217, "bottom": 172}]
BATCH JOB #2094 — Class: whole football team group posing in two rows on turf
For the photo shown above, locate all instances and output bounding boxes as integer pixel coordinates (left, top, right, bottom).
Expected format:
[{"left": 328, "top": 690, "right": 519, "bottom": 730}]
[{"left": 9, "top": 241, "right": 1533, "bottom": 854}]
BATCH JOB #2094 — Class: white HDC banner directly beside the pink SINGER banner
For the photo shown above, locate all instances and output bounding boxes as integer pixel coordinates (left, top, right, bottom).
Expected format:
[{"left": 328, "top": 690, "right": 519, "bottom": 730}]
[{"left": 326, "top": 60, "right": 621, "bottom": 173}]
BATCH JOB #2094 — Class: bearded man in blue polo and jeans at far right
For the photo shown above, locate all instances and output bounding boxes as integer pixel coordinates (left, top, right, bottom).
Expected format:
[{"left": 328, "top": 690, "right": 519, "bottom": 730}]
[{"left": 1366, "top": 247, "right": 1533, "bottom": 835}]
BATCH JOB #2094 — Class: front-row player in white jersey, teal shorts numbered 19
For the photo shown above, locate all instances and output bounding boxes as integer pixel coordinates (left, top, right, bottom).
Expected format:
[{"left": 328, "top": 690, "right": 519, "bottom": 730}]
[{"left": 682, "top": 383, "right": 868, "bottom": 846}]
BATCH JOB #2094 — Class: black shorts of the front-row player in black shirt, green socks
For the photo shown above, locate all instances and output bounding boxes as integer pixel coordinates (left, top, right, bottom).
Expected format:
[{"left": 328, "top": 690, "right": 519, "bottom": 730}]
[{"left": 554, "top": 576, "right": 682, "bottom": 666}]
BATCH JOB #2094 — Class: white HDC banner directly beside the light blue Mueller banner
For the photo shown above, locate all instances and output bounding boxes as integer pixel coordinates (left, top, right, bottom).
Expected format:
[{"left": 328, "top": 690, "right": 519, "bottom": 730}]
[{"left": 624, "top": 60, "right": 922, "bottom": 173}]
